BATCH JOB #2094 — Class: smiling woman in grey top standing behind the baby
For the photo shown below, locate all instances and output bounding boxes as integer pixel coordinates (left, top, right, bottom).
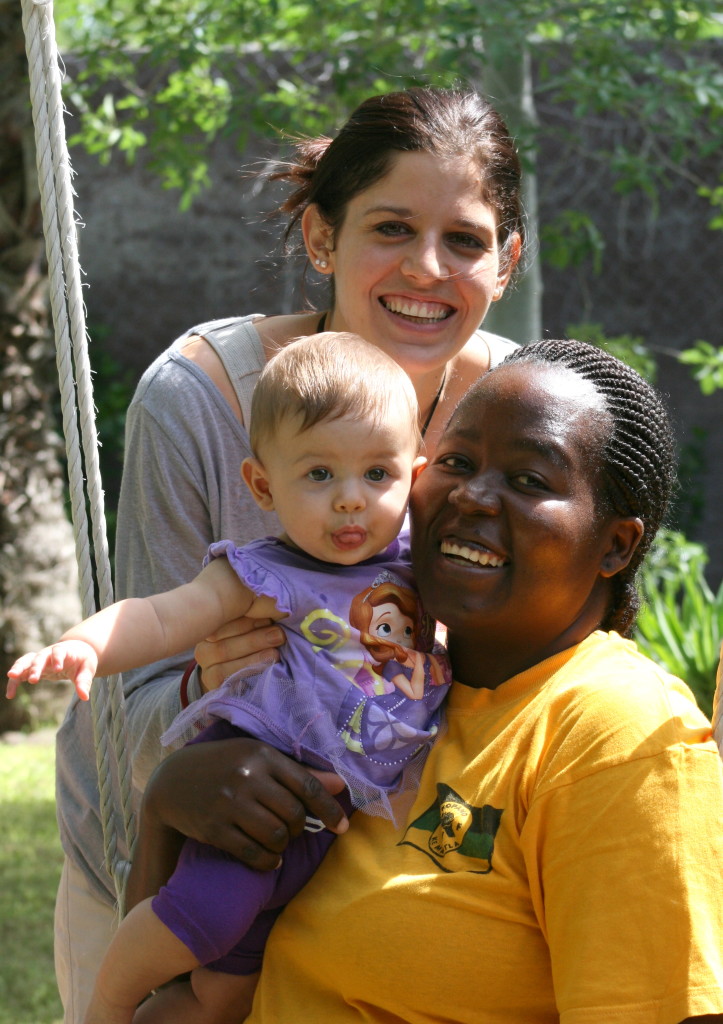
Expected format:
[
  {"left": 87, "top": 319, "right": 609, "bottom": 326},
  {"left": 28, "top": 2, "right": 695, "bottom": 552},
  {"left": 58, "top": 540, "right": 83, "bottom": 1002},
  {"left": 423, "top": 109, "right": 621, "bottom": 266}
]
[{"left": 55, "top": 89, "right": 523, "bottom": 1024}]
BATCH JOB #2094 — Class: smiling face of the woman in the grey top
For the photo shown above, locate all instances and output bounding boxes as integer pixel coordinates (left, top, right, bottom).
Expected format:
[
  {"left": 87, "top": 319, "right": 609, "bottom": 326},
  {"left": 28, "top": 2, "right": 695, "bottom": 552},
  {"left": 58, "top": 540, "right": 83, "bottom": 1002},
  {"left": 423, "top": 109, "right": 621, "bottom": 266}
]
[{"left": 304, "top": 153, "right": 514, "bottom": 381}]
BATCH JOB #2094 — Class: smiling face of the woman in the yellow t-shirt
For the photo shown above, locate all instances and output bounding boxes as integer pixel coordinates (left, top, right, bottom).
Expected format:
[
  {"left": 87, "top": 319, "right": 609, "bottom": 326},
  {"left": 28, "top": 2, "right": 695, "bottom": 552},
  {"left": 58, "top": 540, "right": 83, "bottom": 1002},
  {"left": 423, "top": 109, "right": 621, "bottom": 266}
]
[{"left": 411, "top": 364, "right": 641, "bottom": 686}]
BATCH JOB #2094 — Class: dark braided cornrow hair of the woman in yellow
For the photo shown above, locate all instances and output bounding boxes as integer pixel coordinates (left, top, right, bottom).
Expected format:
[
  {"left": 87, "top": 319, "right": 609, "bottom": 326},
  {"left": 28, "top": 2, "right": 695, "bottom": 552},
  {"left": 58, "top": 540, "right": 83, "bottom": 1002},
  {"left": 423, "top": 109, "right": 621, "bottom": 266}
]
[{"left": 497, "top": 340, "right": 675, "bottom": 636}]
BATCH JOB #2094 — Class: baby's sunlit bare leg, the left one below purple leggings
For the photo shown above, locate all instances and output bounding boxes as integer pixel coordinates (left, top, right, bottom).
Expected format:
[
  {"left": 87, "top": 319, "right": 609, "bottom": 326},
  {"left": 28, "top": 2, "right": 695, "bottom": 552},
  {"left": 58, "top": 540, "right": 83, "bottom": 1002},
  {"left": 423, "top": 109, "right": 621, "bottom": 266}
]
[{"left": 84, "top": 899, "right": 199, "bottom": 1024}]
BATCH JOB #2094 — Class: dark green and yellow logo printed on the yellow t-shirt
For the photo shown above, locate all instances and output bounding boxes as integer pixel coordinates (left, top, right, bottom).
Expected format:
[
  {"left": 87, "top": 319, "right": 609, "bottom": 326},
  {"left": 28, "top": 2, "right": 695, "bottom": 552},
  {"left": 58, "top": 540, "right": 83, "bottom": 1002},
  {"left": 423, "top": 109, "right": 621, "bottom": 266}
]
[{"left": 399, "top": 782, "right": 502, "bottom": 874}]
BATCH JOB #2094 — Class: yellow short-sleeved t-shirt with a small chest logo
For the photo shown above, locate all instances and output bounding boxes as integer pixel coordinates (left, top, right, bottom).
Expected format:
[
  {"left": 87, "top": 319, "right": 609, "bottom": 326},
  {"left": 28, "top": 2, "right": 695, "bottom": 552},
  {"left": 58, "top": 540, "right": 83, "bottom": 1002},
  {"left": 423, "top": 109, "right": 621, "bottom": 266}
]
[{"left": 249, "top": 633, "right": 723, "bottom": 1024}]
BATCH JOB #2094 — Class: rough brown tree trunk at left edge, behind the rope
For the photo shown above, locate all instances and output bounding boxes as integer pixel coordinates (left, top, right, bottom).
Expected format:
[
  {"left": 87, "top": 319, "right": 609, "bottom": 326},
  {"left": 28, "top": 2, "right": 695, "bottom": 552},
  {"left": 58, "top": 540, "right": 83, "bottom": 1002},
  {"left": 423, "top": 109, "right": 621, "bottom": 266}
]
[{"left": 0, "top": 0, "right": 81, "bottom": 732}]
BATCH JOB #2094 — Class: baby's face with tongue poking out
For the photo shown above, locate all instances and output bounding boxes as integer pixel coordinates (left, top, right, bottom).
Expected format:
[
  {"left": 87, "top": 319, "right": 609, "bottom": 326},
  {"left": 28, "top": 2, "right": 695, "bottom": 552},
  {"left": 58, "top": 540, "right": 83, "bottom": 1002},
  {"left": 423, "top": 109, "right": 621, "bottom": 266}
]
[{"left": 248, "top": 402, "right": 424, "bottom": 565}]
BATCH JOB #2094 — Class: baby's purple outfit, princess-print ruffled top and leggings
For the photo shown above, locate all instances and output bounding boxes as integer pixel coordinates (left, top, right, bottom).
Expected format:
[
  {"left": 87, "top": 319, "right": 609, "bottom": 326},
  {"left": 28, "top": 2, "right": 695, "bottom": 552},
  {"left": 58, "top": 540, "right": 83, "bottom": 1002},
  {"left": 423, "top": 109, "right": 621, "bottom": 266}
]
[{"left": 153, "top": 538, "right": 451, "bottom": 974}]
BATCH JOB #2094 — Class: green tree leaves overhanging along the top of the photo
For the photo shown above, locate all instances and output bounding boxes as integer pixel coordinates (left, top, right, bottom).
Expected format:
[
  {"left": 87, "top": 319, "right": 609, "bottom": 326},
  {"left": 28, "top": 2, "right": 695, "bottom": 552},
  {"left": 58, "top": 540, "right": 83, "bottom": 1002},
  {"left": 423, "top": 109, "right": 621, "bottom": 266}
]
[{"left": 62, "top": 0, "right": 723, "bottom": 218}]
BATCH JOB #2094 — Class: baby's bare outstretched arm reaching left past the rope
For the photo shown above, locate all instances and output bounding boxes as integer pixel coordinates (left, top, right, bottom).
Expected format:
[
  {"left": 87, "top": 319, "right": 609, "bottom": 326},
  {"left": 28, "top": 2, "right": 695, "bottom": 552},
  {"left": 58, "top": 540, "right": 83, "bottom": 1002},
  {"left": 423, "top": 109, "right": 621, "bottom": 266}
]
[{"left": 7, "top": 558, "right": 280, "bottom": 699}]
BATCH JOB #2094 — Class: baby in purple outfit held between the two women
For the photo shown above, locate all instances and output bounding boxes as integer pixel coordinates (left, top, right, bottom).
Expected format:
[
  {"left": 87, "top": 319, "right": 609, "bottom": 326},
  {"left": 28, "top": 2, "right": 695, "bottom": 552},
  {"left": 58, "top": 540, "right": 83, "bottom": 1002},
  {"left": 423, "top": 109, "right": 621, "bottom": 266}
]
[{"left": 7, "top": 333, "right": 451, "bottom": 1024}]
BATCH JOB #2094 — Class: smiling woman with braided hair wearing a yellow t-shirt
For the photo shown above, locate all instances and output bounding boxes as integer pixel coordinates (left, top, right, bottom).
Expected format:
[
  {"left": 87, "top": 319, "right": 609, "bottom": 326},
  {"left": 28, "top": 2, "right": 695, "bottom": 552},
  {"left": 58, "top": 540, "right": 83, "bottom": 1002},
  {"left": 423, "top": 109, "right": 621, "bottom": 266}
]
[{"left": 218, "top": 341, "right": 723, "bottom": 1024}]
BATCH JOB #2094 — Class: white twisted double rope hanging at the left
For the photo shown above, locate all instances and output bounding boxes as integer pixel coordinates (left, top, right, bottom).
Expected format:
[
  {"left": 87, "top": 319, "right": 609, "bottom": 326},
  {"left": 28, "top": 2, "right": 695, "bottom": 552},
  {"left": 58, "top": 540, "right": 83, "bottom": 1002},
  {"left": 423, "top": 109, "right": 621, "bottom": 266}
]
[{"left": 23, "top": 0, "right": 135, "bottom": 912}]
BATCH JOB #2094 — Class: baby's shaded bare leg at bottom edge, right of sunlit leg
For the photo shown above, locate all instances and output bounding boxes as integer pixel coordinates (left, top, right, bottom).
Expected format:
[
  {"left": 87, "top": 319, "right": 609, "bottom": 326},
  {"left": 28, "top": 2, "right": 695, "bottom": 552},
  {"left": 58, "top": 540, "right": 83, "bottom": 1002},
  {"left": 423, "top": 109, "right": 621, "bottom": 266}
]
[{"left": 132, "top": 967, "right": 259, "bottom": 1024}]
